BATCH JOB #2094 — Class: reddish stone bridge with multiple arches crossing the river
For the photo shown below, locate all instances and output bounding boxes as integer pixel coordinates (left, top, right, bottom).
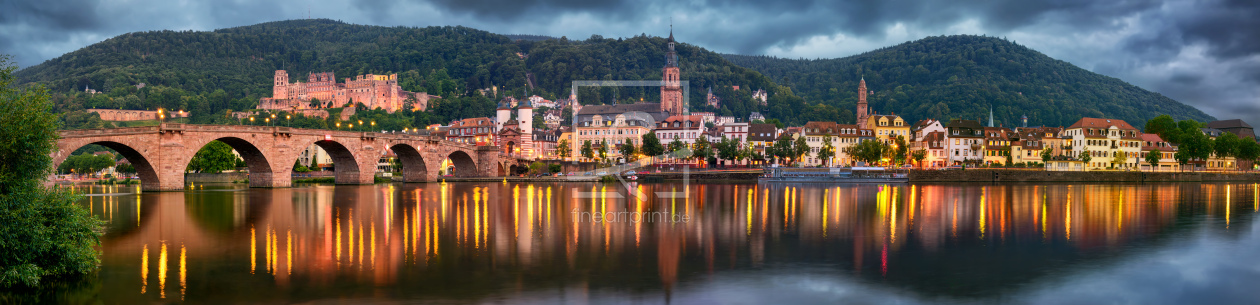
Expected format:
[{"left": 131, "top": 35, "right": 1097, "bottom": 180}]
[{"left": 53, "top": 124, "right": 517, "bottom": 190}]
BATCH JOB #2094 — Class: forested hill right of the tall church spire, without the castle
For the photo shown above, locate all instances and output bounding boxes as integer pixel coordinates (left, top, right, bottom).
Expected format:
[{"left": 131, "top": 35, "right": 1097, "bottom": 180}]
[{"left": 723, "top": 35, "right": 1215, "bottom": 126}]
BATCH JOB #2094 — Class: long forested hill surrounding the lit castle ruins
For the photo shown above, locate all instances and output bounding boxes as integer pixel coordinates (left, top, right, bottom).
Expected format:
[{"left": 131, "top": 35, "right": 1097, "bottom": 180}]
[{"left": 16, "top": 19, "right": 816, "bottom": 124}]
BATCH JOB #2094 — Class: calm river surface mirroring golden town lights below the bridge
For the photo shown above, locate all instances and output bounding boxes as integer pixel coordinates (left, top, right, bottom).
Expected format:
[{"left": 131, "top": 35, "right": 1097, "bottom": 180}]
[{"left": 9, "top": 183, "right": 1260, "bottom": 304}]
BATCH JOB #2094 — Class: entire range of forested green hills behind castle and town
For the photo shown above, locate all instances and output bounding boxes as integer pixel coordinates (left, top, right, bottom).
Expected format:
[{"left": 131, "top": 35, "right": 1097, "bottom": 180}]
[{"left": 16, "top": 19, "right": 1211, "bottom": 129}]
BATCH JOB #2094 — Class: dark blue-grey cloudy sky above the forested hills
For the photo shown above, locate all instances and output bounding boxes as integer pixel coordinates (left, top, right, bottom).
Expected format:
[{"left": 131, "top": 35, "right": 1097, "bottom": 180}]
[{"left": 0, "top": 0, "right": 1260, "bottom": 124}]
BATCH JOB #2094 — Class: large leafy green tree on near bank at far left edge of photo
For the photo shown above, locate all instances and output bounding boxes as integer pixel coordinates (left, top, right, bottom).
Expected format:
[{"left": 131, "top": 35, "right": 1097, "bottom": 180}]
[{"left": 0, "top": 55, "right": 102, "bottom": 287}]
